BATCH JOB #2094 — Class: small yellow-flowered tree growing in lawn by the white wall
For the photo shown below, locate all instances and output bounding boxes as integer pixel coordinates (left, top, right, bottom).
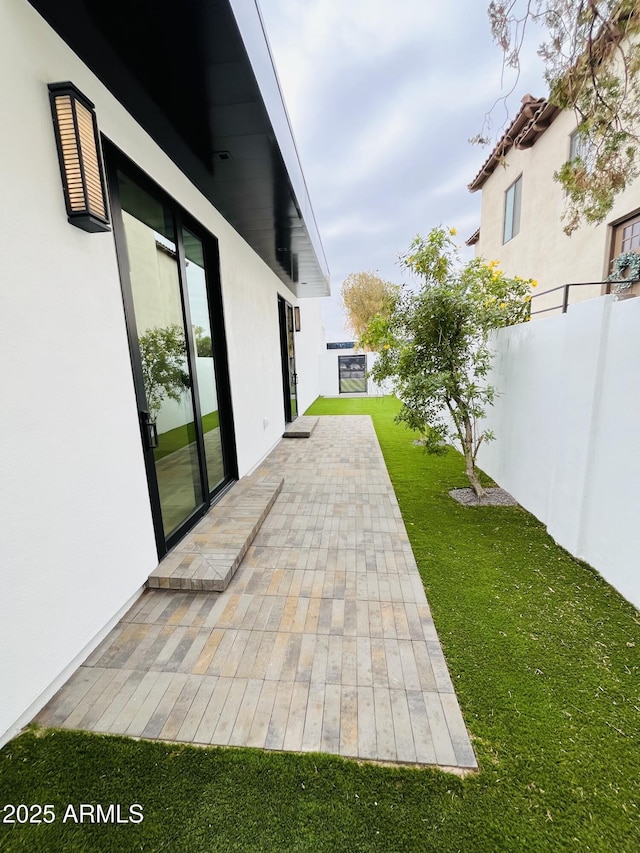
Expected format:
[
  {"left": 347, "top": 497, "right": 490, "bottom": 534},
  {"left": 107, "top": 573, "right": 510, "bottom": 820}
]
[{"left": 365, "top": 226, "right": 536, "bottom": 497}]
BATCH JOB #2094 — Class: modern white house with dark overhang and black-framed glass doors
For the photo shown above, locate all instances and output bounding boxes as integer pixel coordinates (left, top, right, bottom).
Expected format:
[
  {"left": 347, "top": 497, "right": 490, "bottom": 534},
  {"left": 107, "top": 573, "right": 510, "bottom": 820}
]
[{"left": 0, "top": 0, "right": 329, "bottom": 743}]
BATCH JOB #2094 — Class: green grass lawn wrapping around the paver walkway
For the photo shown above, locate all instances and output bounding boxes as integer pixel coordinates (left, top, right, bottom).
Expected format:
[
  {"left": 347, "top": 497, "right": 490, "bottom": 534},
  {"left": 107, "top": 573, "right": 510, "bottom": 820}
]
[{"left": 0, "top": 398, "right": 640, "bottom": 853}]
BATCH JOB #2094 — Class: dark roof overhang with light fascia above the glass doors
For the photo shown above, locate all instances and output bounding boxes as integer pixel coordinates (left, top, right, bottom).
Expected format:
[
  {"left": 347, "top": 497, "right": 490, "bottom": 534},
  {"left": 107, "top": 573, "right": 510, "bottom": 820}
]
[{"left": 30, "top": 0, "right": 330, "bottom": 297}]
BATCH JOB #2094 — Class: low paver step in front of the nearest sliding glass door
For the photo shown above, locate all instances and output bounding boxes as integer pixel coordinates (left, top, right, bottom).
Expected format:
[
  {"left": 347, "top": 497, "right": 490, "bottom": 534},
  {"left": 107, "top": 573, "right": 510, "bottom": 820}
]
[{"left": 147, "top": 474, "right": 284, "bottom": 592}]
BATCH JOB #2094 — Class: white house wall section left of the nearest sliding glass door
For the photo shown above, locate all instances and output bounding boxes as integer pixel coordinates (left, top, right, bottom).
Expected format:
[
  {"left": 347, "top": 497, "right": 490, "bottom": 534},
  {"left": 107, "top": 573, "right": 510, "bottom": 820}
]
[{"left": 0, "top": 0, "right": 157, "bottom": 736}]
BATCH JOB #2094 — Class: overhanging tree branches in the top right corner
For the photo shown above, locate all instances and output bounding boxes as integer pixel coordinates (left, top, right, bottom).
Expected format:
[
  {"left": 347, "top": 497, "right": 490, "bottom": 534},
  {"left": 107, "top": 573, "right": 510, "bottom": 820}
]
[{"left": 482, "top": 0, "right": 640, "bottom": 234}]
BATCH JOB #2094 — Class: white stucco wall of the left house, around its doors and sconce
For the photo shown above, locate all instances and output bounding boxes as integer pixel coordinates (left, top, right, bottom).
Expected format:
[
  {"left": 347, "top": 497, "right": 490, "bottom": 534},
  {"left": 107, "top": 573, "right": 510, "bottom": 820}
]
[{"left": 0, "top": 0, "right": 321, "bottom": 743}]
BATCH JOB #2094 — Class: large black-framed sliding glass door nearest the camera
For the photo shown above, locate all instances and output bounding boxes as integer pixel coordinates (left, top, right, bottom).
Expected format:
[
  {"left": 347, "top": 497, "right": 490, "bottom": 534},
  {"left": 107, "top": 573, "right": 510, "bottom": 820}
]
[{"left": 110, "top": 152, "right": 237, "bottom": 557}]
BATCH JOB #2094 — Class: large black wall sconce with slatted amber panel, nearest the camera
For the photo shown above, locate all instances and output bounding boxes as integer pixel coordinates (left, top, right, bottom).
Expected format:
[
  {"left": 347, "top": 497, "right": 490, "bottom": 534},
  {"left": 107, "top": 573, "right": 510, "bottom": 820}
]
[{"left": 49, "top": 82, "right": 111, "bottom": 232}]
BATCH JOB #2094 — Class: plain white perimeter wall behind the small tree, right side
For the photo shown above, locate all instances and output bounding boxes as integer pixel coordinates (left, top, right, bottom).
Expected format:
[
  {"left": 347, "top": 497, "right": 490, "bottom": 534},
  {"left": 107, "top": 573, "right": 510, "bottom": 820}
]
[{"left": 478, "top": 296, "right": 640, "bottom": 606}]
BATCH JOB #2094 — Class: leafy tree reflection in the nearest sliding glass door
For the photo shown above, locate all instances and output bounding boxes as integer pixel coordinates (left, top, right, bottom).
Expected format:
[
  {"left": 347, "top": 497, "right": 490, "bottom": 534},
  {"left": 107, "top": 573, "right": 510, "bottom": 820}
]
[{"left": 139, "top": 323, "right": 191, "bottom": 420}]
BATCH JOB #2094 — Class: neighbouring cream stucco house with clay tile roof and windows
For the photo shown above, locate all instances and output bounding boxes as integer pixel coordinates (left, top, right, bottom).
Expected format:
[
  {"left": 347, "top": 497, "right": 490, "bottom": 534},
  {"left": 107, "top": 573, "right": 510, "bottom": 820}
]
[{"left": 467, "top": 95, "right": 640, "bottom": 317}]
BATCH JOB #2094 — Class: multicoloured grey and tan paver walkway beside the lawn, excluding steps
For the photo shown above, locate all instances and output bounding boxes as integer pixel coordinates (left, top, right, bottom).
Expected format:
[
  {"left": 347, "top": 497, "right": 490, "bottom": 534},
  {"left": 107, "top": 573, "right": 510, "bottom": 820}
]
[{"left": 38, "top": 416, "right": 476, "bottom": 768}]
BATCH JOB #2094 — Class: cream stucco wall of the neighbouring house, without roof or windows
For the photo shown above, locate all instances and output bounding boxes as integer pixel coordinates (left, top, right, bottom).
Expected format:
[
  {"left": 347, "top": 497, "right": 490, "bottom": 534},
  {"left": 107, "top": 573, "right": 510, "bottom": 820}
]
[{"left": 476, "top": 112, "right": 640, "bottom": 310}]
